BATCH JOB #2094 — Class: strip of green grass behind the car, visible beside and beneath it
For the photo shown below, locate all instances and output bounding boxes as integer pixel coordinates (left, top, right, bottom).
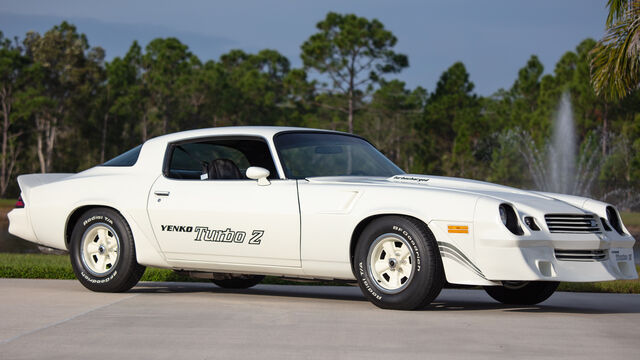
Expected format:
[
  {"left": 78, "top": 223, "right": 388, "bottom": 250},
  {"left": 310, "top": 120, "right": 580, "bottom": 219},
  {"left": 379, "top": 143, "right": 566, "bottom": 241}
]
[{"left": 0, "top": 253, "right": 640, "bottom": 294}]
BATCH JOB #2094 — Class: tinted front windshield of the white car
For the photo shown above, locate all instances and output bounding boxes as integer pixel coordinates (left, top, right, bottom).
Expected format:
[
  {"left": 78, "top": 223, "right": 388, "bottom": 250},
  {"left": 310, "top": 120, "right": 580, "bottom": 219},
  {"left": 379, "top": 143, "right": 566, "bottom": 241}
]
[{"left": 274, "top": 132, "right": 404, "bottom": 179}]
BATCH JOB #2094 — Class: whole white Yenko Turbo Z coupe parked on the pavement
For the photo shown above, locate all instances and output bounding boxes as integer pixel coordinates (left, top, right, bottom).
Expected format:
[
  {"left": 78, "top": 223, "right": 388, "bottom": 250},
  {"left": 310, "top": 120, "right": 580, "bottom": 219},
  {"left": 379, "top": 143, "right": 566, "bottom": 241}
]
[{"left": 9, "top": 127, "right": 638, "bottom": 309}]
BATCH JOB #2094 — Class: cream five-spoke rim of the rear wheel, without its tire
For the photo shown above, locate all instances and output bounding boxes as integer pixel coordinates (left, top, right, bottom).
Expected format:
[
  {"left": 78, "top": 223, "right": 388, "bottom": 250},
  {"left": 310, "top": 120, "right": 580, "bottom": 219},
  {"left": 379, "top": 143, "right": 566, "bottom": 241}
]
[{"left": 80, "top": 223, "right": 120, "bottom": 276}]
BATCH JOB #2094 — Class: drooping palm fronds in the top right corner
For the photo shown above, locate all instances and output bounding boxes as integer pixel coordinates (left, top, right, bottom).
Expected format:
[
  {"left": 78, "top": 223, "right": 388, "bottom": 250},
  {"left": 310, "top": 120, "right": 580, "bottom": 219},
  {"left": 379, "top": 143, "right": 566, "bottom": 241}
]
[{"left": 591, "top": 0, "right": 640, "bottom": 101}]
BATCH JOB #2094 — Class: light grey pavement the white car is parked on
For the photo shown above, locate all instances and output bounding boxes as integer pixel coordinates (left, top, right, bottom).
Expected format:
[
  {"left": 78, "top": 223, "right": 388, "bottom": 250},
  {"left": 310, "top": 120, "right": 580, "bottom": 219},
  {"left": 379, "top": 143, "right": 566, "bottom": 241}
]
[{"left": 0, "top": 279, "right": 640, "bottom": 360}]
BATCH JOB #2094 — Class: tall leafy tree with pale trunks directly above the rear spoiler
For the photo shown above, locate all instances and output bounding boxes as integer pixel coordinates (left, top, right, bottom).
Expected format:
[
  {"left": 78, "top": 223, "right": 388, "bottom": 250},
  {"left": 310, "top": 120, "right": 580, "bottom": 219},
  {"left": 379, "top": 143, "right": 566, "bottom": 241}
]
[{"left": 24, "top": 22, "right": 104, "bottom": 173}]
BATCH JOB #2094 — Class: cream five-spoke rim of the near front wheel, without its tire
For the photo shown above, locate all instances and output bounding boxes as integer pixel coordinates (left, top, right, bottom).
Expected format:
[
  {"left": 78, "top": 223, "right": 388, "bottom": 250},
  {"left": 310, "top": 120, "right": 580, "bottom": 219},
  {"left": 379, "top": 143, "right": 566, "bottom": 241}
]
[{"left": 367, "top": 233, "right": 415, "bottom": 294}]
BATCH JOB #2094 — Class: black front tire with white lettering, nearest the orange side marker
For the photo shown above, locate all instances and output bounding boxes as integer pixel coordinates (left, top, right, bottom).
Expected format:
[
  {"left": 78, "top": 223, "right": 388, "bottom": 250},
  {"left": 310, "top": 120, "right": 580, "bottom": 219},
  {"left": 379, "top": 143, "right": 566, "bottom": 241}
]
[{"left": 353, "top": 216, "right": 445, "bottom": 310}]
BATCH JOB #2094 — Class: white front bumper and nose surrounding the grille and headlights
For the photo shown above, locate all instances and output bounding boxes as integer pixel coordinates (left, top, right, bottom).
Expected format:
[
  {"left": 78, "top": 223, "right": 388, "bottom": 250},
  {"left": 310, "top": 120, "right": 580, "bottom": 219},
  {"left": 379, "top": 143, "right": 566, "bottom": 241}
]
[{"left": 474, "top": 200, "right": 638, "bottom": 282}]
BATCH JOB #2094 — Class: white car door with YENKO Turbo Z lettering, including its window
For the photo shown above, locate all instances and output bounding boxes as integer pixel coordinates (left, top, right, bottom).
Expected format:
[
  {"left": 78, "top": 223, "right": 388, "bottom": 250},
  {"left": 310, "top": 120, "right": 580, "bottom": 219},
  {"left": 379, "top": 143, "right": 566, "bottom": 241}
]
[{"left": 147, "top": 137, "right": 300, "bottom": 267}]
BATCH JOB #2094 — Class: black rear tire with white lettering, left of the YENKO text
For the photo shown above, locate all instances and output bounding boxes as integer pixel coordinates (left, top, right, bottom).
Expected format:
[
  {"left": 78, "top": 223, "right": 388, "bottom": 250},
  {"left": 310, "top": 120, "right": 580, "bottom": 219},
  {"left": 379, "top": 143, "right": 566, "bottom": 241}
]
[{"left": 69, "top": 208, "right": 145, "bottom": 292}]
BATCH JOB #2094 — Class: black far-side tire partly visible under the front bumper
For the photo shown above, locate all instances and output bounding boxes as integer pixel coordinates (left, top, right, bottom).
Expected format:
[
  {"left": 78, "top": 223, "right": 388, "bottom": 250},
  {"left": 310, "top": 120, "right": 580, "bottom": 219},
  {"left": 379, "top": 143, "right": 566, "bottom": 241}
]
[{"left": 484, "top": 281, "right": 560, "bottom": 305}]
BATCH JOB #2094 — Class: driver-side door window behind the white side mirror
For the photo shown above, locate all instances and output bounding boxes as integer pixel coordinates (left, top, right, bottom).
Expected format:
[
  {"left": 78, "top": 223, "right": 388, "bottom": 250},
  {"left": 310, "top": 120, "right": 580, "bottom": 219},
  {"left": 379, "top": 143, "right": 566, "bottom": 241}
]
[{"left": 165, "top": 138, "right": 277, "bottom": 180}]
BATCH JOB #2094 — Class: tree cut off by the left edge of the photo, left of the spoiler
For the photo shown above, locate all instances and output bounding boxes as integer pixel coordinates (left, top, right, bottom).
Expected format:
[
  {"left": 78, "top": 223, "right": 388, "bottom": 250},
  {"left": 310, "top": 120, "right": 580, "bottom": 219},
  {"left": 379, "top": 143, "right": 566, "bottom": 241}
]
[{"left": 0, "top": 32, "right": 28, "bottom": 197}]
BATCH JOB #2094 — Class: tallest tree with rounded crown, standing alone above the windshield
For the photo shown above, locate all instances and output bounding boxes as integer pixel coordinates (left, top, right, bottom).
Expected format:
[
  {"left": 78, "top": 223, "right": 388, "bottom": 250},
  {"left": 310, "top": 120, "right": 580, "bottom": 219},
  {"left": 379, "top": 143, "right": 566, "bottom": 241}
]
[{"left": 301, "top": 12, "right": 409, "bottom": 133}]
